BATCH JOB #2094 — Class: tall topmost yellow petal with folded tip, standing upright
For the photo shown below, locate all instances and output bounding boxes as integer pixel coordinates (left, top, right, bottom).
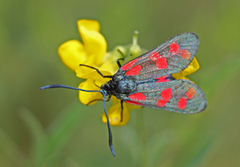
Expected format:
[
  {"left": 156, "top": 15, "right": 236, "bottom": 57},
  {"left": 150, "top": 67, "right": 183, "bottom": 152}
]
[{"left": 78, "top": 20, "right": 107, "bottom": 65}]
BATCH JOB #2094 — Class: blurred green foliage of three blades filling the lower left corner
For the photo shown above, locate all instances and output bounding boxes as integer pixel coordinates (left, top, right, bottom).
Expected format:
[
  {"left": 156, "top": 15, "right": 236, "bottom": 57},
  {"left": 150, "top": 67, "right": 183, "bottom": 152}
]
[{"left": 0, "top": 102, "right": 86, "bottom": 166}]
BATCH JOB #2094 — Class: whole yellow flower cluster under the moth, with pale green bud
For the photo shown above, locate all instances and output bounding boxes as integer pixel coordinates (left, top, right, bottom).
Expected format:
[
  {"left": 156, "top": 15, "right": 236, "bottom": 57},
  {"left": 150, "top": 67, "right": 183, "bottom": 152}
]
[{"left": 58, "top": 20, "right": 199, "bottom": 126}]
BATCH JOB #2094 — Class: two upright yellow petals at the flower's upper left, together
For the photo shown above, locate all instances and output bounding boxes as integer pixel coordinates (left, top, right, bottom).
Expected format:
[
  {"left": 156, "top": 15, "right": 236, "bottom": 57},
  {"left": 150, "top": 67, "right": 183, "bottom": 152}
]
[{"left": 58, "top": 20, "right": 107, "bottom": 71}]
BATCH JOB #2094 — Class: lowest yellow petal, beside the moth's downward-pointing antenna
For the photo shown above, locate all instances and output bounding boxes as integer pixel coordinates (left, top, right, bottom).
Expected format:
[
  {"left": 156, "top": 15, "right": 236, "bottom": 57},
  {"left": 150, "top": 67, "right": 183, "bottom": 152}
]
[{"left": 102, "top": 103, "right": 130, "bottom": 126}]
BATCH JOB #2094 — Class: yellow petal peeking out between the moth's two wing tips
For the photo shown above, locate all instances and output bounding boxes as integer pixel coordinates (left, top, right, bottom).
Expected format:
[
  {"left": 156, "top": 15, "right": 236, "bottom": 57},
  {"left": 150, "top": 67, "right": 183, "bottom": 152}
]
[{"left": 172, "top": 57, "right": 199, "bottom": 79}]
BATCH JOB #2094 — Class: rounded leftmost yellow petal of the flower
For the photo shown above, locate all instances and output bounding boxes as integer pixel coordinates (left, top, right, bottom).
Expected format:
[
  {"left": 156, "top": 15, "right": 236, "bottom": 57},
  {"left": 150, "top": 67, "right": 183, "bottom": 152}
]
[{"left": 58, "top": 40, "right": 87, "bottom": 71}]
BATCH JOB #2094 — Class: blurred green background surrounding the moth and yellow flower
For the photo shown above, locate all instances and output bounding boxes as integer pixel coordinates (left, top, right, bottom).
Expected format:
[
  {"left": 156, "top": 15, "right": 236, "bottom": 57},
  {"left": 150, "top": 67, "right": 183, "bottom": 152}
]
[{"left": 0, "top": 0, "right": 240, "bottom": 167}]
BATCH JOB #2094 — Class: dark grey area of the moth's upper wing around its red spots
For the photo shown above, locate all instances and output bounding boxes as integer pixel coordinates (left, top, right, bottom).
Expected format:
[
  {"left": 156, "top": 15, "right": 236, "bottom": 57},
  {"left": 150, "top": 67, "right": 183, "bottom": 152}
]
[{"left": 116, "top": 32, "right": 199, "bottom": 81}]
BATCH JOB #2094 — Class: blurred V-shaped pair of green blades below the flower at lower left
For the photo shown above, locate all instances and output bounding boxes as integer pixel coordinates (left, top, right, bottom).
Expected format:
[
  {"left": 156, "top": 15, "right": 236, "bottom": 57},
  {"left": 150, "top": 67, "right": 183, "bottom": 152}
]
[{"left": 20, "top": 101, "right": 89, "bottom": 166}]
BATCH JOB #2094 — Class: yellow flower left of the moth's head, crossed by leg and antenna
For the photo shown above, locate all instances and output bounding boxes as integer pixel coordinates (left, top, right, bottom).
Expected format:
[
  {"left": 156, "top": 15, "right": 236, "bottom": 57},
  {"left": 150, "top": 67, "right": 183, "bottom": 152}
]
[{"left": 58, "top": 20, "right": 112, "bottom": 104}]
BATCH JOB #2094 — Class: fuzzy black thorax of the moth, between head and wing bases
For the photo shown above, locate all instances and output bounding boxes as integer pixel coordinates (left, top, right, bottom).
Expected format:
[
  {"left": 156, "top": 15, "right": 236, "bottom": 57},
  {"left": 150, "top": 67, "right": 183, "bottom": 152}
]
[{"left": 115, "top": 80, "right": 137, "bottom": 94}]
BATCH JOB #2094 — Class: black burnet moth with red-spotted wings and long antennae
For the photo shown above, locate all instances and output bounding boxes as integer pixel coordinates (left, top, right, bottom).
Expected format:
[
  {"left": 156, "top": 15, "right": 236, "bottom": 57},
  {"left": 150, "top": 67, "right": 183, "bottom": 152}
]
[{"left": 40, "top": 33, "right": 207, "bottom": 156}]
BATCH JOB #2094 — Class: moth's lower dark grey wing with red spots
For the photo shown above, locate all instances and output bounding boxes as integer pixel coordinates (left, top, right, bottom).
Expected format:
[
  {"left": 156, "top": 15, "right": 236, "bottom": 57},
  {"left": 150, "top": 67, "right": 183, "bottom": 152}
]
[{"left": 117, "top": 79, "right": 207, "bottom": 114}]
